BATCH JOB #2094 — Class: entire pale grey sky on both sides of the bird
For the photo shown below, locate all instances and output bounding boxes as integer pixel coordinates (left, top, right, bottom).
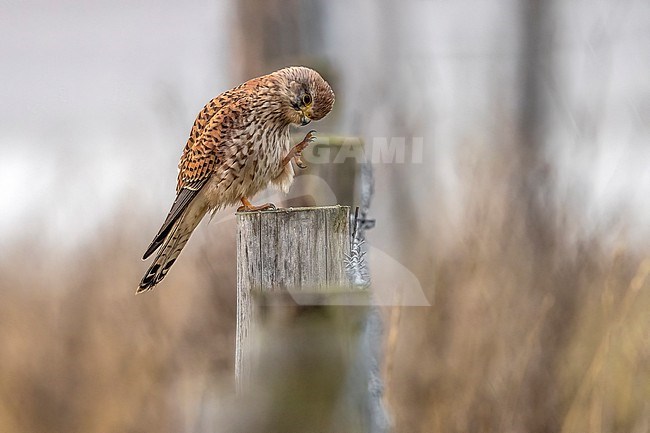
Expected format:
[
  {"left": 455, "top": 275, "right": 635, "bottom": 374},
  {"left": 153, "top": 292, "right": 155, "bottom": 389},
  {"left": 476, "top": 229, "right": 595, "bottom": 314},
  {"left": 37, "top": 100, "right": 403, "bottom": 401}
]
[{"left": 0, "top": 0, "right": 650, "bottom": 250}]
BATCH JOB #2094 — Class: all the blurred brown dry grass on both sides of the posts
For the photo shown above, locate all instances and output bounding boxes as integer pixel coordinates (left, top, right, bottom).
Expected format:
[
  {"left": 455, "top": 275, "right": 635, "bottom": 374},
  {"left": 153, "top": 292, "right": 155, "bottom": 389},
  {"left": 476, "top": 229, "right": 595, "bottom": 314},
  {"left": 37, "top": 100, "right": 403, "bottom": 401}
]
[{"left": 0, "top": 143, "right": 650, "bottom": 433}]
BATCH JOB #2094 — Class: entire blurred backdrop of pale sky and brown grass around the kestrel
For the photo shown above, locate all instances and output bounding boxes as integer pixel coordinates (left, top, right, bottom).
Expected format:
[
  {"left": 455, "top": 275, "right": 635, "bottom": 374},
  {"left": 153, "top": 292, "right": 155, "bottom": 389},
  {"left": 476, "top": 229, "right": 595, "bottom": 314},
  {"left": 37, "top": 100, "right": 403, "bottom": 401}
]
[{"left": 0, "top": 0, "right": 650, "bottom": 433}]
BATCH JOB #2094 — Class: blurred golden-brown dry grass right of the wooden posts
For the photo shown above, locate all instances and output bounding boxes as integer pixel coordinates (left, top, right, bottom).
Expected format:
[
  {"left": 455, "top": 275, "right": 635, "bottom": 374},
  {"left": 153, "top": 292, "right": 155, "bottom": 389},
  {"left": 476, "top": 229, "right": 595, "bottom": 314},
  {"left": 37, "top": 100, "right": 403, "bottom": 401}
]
[{"left": 387, "top": 143, "right": 650, "bottom": 433}]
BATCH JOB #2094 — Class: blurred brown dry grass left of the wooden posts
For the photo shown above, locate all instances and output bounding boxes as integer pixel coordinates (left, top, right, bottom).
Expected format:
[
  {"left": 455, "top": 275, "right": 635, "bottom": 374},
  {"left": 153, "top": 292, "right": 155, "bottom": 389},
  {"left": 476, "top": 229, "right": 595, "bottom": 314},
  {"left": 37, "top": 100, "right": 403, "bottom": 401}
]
[{"left": 0, "top": 210, "right": 235, "bottom": 432}]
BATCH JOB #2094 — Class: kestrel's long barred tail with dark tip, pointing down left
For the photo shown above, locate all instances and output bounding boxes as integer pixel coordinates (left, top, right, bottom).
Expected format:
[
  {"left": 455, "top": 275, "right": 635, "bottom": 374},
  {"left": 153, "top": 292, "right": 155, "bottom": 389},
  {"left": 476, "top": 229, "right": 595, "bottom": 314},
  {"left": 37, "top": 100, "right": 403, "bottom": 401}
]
[{"left": 136, "top": 213, "right": 203, "bottom": 293}]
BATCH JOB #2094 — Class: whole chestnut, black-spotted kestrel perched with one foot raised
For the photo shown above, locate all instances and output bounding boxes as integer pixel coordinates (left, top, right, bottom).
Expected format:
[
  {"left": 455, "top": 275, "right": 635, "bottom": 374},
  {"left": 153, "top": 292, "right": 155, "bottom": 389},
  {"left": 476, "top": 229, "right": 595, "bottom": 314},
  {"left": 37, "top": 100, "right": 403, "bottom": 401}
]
[{"left": 137, "top": 66, "right": 334, "bottom": 293}]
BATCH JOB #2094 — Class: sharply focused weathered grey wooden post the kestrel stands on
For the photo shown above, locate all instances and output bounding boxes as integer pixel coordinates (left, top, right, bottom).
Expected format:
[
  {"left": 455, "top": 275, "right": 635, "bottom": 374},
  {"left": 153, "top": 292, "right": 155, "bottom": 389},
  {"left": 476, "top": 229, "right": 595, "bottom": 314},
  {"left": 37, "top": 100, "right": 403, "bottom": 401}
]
[{"left": 235, "top": 206, "right": 350, "bottom": 389}]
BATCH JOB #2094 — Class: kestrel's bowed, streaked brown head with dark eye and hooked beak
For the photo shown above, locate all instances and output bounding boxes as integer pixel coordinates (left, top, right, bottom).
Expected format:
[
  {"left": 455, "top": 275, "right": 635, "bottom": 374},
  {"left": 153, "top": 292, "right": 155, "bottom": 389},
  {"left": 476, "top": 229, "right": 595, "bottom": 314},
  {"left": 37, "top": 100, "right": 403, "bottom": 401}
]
[{"left": 272, "top": 66, "right": 334, "bottom": 126}]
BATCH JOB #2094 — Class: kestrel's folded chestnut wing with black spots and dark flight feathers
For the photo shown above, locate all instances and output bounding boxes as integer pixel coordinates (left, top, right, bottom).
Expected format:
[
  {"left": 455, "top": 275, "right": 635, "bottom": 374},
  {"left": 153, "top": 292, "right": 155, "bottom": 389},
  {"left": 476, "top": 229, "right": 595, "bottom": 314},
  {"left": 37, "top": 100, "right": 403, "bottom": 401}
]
[{"left": 142, "top": 92, "right": 243, "bottom": 260}]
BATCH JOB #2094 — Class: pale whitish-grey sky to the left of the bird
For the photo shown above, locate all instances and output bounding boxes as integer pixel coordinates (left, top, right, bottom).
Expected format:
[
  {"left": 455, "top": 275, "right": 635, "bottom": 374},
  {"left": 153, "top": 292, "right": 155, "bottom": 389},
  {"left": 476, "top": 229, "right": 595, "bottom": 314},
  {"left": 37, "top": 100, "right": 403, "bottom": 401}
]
[{"left": 0, "top": 0, "right": 230, "bottom": 246}]
